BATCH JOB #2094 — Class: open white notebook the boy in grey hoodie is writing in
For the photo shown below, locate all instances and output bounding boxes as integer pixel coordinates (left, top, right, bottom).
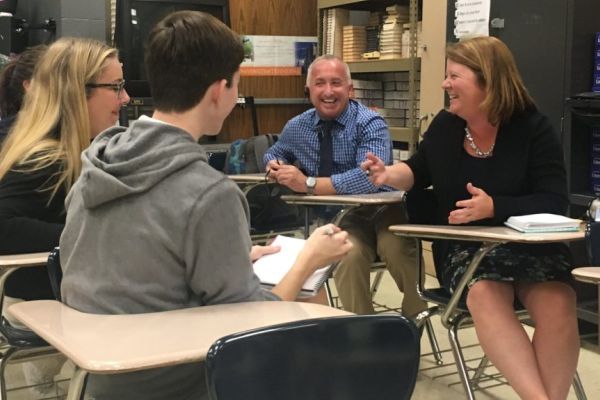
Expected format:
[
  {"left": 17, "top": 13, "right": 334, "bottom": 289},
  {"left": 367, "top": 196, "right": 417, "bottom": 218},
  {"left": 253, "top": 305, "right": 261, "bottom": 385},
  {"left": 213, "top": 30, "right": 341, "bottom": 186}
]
[{"left": 254, "top": 235, "right": 335, "bottom": 295}]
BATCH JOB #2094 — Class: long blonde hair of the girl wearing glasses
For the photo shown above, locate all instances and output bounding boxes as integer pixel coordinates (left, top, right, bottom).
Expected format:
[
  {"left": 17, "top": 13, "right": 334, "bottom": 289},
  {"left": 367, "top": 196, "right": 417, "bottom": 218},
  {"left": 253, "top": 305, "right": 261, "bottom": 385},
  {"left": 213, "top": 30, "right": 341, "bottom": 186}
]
[{"left": 0, "top": 37, "right": 117, "bottom": 198}]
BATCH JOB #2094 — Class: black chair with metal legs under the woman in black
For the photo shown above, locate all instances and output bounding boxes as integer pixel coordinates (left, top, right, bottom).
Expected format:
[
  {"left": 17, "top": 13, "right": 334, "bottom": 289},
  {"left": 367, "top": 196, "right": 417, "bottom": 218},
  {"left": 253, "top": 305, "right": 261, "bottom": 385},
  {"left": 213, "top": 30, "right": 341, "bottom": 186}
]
[{"left": 406, "top": 189, "right": 587, "bottom": 400}]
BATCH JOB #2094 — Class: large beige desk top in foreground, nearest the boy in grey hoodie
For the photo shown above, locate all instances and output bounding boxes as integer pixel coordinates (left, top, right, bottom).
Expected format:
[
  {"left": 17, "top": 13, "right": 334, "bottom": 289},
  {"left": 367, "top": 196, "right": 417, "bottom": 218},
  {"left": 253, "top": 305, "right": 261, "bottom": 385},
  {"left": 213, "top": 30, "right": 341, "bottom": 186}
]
[{"left": 8, "top": 300, "right": 351, "bottom": 374}]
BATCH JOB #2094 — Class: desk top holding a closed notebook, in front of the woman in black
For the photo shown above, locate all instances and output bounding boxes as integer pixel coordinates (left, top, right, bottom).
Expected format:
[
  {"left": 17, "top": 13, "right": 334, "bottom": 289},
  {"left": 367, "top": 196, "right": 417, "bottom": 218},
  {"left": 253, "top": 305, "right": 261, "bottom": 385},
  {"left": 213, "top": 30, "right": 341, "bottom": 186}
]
[{"left": 390, "top": 224, "right": 585, "bottom": 244}]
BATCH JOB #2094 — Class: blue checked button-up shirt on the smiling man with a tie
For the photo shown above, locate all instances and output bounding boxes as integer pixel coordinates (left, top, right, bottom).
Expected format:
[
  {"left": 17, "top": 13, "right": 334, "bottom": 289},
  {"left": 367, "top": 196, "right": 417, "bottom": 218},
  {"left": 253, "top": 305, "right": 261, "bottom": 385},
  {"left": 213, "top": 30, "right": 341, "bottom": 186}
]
[{"left": 263, "top": 100, "right": 392, "bottom": 194}]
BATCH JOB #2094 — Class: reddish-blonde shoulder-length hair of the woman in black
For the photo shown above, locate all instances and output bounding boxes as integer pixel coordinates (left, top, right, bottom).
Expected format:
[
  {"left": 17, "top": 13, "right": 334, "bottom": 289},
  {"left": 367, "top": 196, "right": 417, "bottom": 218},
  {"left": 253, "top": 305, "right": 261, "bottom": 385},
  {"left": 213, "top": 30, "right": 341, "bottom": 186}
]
[{"left": 446, "top": 36, "right": 535, "bottom": 125}]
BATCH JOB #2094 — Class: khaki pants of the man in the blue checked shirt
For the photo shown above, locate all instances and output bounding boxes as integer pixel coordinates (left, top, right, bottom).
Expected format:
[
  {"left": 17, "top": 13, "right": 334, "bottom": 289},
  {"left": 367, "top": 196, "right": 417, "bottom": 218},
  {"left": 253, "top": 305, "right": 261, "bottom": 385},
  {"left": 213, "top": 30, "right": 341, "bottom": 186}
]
[{"left": 334, "top": 204, "right": 427, "bottom": 317}]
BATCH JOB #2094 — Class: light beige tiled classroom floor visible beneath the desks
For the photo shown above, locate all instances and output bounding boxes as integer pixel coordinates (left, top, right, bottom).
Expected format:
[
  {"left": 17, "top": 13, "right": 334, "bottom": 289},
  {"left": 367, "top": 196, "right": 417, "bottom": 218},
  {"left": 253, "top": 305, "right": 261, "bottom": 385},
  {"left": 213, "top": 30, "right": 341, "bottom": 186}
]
[{"left": 6, "top": 272, "right": 600, "bottom": 400}]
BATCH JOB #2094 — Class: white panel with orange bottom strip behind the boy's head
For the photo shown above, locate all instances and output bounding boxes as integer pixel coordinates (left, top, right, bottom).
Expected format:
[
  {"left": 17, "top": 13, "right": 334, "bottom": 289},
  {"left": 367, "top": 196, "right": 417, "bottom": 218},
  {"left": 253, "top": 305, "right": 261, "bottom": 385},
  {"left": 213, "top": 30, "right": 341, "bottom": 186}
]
[{"left": 240, "top": 35, "right": 317, "bottom": 76}]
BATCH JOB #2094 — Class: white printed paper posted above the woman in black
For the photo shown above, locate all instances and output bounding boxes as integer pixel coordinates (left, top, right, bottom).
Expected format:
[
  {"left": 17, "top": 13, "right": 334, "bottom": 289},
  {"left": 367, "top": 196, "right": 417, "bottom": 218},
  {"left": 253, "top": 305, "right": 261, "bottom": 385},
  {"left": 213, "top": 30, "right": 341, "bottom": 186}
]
[{"left": 454, "top": 0, "right": 491, "bottom": 39}]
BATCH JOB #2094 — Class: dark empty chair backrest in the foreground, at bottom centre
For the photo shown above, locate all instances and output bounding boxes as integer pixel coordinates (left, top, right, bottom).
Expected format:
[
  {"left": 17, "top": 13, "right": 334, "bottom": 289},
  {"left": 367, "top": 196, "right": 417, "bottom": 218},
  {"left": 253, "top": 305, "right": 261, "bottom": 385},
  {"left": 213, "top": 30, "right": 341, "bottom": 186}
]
[{"left": 206, "top": 314, "right": 420, "bottom": 400}]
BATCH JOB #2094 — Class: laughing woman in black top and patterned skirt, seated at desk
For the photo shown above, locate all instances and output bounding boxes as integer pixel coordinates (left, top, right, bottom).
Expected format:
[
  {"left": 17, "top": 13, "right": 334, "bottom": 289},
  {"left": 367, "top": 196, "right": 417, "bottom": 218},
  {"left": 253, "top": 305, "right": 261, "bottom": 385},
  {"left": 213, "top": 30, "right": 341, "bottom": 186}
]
[{"left": 362, "top": 37, "right": 579, "bottom": 399}]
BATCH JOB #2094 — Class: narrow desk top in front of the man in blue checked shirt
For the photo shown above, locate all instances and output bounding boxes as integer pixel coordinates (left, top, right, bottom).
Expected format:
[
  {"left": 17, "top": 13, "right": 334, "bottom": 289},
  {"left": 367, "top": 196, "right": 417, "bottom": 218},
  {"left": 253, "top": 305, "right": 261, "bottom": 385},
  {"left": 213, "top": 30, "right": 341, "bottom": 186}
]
[{"left": 281, "top": 191, "right": 404, "bottom": 206}]
